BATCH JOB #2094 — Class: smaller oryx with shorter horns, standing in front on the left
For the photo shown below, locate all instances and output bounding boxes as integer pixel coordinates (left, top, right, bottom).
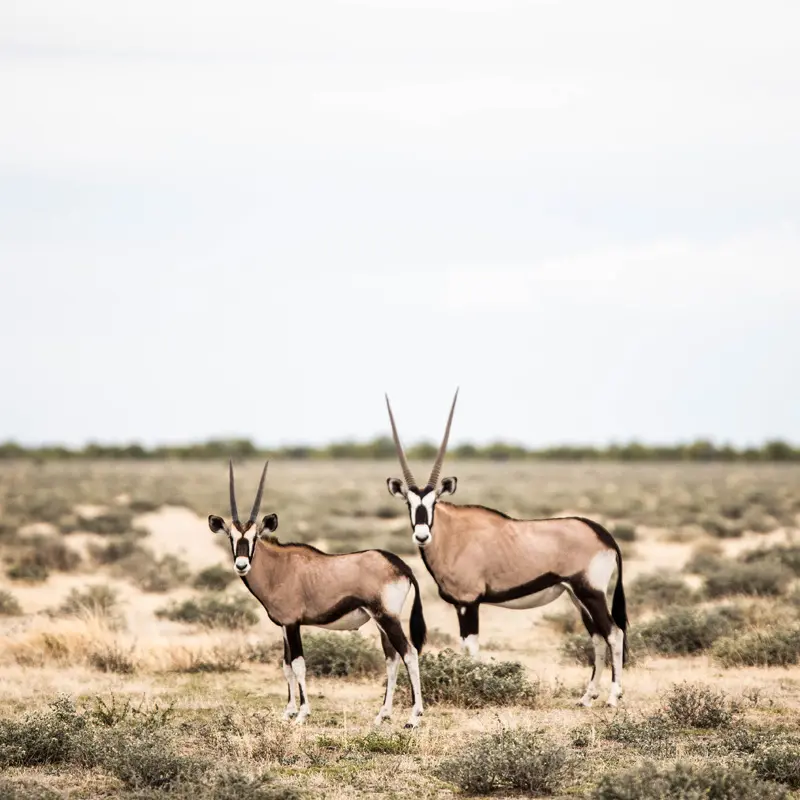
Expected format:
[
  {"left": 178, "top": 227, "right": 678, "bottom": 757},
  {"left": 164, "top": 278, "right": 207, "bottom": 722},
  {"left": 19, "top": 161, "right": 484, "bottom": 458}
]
[{"left": 208, "top": 462, "right": 426, "bottom": 728}]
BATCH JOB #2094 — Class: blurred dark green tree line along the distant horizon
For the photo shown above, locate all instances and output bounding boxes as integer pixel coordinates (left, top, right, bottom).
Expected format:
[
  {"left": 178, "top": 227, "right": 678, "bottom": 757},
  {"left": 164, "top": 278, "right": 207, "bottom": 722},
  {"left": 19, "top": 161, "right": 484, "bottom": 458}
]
[{"left": 0, "top": 437, "right": 800, "bottom": 462}]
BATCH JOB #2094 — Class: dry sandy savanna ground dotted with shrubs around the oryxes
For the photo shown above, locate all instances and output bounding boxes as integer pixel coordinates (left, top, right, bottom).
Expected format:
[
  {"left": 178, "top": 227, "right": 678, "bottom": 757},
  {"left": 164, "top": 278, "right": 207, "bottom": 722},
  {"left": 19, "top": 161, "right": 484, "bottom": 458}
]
[{"left": 0, "top": 461, "right": 800, "bottom": 800}]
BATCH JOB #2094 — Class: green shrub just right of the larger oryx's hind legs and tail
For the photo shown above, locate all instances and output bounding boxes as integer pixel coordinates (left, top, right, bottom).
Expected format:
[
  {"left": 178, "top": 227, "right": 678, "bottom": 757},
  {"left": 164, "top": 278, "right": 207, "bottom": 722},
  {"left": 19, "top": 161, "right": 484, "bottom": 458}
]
[{"left": 638, "top": 607, "right": 742, "bottom": 656}]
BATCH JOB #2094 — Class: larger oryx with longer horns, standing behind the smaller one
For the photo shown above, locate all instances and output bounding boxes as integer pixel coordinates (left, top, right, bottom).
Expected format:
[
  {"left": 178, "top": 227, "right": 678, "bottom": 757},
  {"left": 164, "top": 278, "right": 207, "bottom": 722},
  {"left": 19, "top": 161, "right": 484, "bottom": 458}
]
[{"left": 386, "top": 391, "right": 627, "bottom": 706}]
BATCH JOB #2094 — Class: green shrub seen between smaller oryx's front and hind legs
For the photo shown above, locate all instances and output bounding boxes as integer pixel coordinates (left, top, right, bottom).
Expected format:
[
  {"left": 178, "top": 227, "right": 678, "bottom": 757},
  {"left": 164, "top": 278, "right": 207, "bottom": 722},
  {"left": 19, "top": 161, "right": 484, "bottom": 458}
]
[{"left": 303, "top": 632, "right": 386, "bottom": 678}]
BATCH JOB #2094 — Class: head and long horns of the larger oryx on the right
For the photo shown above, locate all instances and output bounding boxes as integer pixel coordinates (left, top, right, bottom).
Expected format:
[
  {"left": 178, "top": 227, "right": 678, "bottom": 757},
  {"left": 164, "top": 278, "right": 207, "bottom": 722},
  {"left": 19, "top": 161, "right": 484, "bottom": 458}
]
[{"left": 386, "top": 389, "right": 458, "bottom": 547}]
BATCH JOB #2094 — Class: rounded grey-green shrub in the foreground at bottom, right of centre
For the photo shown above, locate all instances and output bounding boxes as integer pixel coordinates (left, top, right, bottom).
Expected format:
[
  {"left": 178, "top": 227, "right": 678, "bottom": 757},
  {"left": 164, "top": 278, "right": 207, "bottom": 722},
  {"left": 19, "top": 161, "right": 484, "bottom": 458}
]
[{"left": 436, "top": 730, "right": 575, "bottom": 797}]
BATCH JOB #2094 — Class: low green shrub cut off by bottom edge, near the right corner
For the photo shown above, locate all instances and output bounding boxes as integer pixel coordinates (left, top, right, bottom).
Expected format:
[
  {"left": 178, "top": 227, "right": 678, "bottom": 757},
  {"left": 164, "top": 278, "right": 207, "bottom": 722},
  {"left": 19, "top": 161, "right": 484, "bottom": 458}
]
[{"left": 589, "top": 762, "right": 787, "bottom": 800}]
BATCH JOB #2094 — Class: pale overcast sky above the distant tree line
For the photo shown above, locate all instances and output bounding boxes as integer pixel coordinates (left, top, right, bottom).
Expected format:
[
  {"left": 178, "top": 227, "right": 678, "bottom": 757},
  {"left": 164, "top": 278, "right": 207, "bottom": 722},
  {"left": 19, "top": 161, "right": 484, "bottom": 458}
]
[{"left": 0, "top": 0, "right": 800, "bottom": 446}]
